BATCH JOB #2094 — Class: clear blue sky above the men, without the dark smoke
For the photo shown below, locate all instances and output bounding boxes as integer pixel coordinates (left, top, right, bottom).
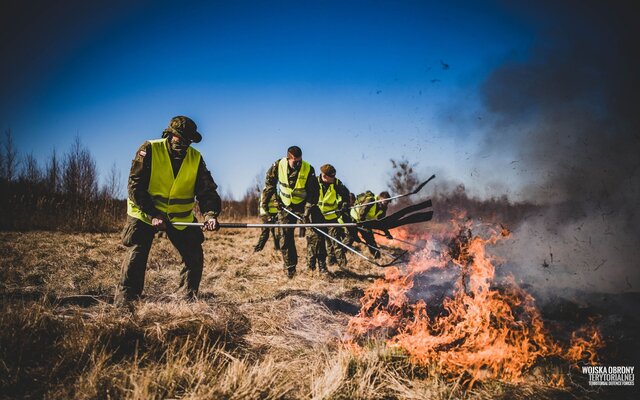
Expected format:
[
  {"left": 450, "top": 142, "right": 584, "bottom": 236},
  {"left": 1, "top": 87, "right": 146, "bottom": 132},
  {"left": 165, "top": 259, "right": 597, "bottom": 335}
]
[{"left": 0, "top": 1, "right": 535, "bottom": 197}]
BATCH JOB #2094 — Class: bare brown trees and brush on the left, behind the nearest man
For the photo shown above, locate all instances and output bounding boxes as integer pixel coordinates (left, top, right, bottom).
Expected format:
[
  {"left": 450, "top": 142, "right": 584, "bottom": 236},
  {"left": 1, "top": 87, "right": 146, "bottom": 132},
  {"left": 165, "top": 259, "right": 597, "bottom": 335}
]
[{"left": 0, "top": 129, "right": 259, "bottom": 232}]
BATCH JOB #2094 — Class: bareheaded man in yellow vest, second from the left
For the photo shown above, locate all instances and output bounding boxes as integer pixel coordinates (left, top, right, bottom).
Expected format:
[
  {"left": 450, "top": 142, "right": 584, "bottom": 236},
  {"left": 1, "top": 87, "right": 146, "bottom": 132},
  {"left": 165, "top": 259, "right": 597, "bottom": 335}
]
[{"left": 262, "top": 146, "right": 322, "bottom": 278}]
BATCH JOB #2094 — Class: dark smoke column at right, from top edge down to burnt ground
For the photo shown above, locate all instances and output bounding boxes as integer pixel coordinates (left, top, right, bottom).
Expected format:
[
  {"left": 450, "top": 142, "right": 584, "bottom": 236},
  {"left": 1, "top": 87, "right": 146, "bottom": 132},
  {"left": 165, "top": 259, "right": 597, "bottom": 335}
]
[{"left": 482, "top": 1, "right": 640, "bottom": 291}]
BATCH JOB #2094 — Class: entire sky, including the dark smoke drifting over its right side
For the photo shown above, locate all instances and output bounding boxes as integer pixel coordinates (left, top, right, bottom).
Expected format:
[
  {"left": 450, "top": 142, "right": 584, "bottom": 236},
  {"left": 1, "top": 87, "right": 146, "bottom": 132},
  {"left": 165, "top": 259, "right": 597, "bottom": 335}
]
[{"left": 0, "top": 0, "right": 640, "bottom": 290}]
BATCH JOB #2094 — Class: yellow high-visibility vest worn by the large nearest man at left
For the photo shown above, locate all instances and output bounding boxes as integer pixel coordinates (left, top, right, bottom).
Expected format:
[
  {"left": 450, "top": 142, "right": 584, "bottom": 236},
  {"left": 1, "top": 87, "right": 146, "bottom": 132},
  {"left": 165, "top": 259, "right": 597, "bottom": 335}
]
[{"left": 127, "top": 139, "right": 201, "bottom": 230}]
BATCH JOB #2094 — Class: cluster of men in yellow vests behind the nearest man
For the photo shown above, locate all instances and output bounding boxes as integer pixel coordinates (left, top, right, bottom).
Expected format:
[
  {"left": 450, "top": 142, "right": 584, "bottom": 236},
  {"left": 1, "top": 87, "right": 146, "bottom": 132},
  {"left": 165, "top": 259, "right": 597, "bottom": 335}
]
[{"left": 254, "top": 146, "right": 389, "bottom": 278}]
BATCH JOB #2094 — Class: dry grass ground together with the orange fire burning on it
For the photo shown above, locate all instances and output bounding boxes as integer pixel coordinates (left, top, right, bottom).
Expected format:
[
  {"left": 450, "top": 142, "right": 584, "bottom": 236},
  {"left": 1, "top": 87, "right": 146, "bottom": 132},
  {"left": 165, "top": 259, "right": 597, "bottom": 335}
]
[{"left": 0, "top": 220, "right": 632, "bottom": 399}]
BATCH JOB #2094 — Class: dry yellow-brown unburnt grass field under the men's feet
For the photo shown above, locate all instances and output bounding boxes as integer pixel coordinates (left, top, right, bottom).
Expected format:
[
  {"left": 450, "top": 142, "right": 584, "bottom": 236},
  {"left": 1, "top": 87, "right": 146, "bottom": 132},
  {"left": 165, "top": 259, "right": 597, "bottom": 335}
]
[{"left": 0, "top": 223, "right": 632, "bottom": 399}]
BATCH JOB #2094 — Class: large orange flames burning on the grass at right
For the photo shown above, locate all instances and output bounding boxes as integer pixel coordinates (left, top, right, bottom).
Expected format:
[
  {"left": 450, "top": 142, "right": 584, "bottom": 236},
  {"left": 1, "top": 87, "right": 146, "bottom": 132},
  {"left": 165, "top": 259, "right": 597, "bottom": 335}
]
[{"left": 348, "top": 216, "right": 602, "bottom": 385}]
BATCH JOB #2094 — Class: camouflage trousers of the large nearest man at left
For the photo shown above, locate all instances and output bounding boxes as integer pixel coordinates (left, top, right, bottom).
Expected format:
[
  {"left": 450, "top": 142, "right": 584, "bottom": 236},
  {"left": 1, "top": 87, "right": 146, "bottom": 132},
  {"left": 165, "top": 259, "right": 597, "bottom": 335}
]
[{"left": 115, "top": 217, "right": 204, "bottom": 303}]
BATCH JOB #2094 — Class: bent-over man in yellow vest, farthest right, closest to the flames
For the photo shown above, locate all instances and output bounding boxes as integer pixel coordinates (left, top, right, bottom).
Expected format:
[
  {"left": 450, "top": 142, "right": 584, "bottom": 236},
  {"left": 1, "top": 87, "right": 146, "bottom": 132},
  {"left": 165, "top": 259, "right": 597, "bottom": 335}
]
[{"left": 351, "top": 190, "right": 393, "bottom": 258}]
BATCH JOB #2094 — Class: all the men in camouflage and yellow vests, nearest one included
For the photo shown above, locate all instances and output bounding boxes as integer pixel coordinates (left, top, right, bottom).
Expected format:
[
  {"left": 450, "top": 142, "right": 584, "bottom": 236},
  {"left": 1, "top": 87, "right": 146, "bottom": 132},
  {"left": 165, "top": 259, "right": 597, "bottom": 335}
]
[{"left": 115, "top": 116, "right": 391, "bottom": 305}]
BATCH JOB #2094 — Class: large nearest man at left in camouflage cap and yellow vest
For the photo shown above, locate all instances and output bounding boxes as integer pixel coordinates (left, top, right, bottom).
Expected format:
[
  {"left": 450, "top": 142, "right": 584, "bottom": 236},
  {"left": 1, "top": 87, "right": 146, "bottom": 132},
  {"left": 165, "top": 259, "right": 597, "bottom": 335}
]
[{"left": 115, "top": 116, "right": 222, "bottom": 305}]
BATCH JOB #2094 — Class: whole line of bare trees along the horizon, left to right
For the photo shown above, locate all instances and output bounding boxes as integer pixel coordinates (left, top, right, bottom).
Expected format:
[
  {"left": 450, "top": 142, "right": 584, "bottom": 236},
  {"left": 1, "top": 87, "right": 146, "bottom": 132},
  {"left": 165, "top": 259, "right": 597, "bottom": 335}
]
[{"left": 0, "top": 130, "right": 535, "bottom": 232}]
